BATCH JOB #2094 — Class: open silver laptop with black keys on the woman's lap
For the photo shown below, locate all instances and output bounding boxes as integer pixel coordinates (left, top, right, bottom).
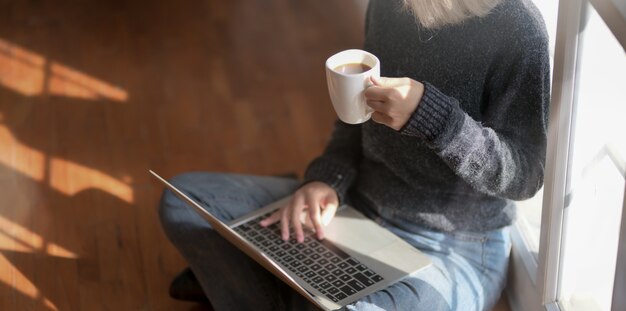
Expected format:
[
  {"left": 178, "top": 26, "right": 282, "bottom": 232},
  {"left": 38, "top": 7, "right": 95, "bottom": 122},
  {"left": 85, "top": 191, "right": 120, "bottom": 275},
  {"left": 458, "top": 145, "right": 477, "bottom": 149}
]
[{"left": 150, "top": 171, "right": 431, "bottom": 310}]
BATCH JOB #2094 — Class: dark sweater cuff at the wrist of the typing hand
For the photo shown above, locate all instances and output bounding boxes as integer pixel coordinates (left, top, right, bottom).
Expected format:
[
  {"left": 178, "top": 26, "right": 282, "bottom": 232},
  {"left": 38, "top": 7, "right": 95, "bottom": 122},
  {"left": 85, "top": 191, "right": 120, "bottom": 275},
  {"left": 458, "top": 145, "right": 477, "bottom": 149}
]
[{"left": 303, "top": 158, "right": 356, "bottom": 204}]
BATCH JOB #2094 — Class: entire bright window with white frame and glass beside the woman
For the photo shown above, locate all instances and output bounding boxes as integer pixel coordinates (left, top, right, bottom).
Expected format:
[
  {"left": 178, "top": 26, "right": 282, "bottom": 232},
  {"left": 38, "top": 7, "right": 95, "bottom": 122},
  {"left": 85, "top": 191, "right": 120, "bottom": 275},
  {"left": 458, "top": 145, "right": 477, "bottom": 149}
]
[{"left": 509, "top": 0, "right": 626, "bottom": 311}]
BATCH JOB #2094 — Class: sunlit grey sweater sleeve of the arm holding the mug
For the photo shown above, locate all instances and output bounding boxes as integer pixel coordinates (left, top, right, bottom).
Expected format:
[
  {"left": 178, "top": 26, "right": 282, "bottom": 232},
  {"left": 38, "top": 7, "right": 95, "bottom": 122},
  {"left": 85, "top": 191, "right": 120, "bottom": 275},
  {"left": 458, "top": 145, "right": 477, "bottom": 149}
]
[{"left": 400, "top": 33, "right": 550, "bottom": 200}]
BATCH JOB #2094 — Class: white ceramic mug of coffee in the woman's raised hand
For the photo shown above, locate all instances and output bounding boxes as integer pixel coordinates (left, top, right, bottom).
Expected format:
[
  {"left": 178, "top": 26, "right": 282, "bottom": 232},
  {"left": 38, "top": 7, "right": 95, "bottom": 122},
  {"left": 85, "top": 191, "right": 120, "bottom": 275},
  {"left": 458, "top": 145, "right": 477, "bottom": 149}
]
[{"left": 326, "top": 49, "right": 380, "bottom": 124}]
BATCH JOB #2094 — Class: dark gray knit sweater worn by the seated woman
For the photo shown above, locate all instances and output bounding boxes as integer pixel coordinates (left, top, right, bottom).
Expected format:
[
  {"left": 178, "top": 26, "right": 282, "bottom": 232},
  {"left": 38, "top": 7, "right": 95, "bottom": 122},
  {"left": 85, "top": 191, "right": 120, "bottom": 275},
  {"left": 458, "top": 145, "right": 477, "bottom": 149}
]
[{"left": 305, "top": 0, "right": 550, "bottom": 232}]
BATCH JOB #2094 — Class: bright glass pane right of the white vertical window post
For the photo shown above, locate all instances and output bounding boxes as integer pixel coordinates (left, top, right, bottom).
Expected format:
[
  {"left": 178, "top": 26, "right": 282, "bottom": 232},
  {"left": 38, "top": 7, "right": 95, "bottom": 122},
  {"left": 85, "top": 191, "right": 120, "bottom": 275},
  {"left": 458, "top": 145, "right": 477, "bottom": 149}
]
[{"left": 558, "top": 6, "right": 626, "bottom": 311}]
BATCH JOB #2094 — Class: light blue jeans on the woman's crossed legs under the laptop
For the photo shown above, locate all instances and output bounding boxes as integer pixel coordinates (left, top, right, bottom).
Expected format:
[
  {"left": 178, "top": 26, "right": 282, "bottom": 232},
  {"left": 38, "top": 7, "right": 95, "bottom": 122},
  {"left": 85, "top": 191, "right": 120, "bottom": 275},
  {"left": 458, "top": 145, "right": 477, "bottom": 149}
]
[{"left": 159, "top": 173, "right": 511, "bottom": 311}]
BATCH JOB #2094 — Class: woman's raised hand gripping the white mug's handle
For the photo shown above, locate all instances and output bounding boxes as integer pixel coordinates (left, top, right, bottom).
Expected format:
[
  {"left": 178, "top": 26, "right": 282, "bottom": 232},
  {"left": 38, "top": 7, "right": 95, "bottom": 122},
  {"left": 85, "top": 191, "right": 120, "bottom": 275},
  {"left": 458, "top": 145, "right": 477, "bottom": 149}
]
[{"left": 365, "top": 77, "right": 424, "bottom": 131}]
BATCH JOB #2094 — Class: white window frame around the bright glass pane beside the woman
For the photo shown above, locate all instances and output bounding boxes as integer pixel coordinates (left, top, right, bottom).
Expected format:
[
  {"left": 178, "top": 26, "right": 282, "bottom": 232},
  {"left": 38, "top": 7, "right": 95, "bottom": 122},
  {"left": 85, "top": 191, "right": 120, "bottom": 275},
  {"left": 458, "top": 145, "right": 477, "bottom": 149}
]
[{"left": 507, "top": 0, "right": 626, "bottom": 311}]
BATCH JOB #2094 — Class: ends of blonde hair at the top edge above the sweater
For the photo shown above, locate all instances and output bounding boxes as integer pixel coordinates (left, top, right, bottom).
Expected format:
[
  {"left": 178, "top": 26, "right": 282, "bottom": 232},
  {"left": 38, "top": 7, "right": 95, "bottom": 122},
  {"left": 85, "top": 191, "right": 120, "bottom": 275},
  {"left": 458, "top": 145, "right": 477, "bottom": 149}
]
[{"left": 404, "top": 0, "right": 501, "bottom": 29}]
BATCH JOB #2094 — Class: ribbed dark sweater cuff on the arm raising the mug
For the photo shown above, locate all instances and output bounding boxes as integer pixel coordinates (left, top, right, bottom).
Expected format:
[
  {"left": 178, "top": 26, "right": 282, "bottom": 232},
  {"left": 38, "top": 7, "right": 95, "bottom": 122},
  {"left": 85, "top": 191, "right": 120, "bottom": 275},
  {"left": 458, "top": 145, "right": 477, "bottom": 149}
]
[{"left": 400, "top": 82, "right": 455, "bottom": 143}]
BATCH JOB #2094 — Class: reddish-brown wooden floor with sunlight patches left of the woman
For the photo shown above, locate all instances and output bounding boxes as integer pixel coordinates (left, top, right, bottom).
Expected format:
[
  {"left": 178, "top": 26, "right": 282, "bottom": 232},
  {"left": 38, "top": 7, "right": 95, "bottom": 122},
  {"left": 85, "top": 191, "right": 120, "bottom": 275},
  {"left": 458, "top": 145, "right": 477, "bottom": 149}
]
[{"left": 0, "top": 0, "right": 507, "bottom": 311}]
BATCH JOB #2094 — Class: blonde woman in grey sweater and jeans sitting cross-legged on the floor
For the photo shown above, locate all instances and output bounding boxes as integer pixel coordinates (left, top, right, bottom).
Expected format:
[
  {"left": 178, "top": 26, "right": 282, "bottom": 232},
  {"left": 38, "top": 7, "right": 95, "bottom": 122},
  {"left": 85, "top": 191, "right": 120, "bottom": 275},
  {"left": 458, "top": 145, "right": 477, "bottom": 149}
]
[{"left": 160, "top": 0, "right": 550, "bottom": 310}]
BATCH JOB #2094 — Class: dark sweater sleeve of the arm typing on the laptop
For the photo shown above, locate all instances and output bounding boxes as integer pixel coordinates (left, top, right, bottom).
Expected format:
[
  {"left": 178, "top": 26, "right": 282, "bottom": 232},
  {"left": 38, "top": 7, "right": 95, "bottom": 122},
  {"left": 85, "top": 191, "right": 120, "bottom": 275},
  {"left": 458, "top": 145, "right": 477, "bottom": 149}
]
[{"left": 304, "top": 120, "right": 362, "bottom": 202}]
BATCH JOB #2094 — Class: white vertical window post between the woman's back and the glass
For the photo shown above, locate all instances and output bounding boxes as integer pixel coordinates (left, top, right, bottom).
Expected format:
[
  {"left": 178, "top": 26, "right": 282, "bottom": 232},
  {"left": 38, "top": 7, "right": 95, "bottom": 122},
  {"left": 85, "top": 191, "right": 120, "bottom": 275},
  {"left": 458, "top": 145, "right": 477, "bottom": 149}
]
[{"left": 536, "top": 0, "right": 585, "bottom": 305}]
